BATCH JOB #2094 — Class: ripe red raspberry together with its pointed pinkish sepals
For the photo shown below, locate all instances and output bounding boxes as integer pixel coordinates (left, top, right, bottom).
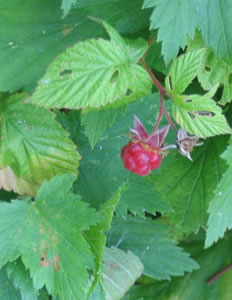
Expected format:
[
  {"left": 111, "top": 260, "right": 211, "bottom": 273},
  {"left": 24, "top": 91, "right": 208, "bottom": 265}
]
[{"left": 121, "top": 116, "right": 169, "bottom": 176}]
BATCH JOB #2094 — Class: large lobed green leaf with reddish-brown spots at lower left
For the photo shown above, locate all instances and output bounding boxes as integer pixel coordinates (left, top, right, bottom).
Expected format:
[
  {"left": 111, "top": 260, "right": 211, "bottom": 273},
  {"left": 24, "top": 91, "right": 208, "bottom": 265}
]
[{"left": 0, "top": 174, "right": 102, "bottom": 300}]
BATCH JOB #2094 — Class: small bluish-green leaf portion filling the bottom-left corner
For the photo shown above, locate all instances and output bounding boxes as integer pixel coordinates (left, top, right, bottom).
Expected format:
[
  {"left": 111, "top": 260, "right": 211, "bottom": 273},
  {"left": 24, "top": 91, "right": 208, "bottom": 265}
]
[{"left": 0, "top": 268, "right": 22, "bottom": 300}]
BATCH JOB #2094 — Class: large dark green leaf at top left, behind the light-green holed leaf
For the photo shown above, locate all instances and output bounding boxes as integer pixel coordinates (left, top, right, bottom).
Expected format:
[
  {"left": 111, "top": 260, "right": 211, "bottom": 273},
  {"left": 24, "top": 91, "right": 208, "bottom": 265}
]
[{"left": 0, "top": 0, "right": 149, "bottom": 91}]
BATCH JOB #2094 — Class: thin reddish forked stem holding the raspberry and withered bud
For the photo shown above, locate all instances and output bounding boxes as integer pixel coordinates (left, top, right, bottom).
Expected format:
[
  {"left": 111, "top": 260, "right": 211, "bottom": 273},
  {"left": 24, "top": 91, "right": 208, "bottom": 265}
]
[{"left": 141, "top": 38, "right": 177, "bottom": 133}]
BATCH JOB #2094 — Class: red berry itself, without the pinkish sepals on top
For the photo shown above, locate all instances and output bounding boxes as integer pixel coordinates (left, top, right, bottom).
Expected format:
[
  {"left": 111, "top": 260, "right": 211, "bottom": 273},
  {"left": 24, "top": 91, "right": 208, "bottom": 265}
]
[{"left": 121, "top": 141, "right": 162, "bottom": 176}]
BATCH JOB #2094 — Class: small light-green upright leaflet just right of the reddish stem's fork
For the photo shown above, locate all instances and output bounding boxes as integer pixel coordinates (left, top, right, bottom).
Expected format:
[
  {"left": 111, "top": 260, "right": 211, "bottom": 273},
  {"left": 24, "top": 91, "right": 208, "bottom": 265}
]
[{"left": 166, "top": 49, "right": 206, "bottom": 94}]
